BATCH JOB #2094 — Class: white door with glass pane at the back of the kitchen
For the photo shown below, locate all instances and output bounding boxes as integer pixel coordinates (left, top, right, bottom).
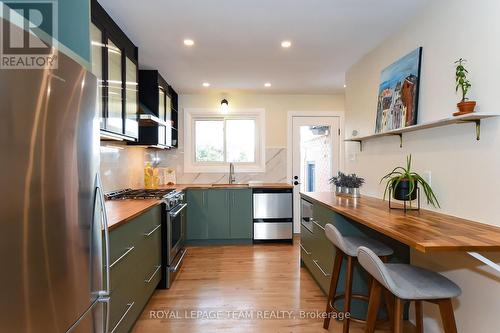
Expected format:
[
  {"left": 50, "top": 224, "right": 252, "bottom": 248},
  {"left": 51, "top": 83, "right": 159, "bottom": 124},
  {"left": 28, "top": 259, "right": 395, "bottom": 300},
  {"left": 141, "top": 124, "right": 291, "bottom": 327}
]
[{"left": 291, "top": 116, "right": 340, "bottom": 233}]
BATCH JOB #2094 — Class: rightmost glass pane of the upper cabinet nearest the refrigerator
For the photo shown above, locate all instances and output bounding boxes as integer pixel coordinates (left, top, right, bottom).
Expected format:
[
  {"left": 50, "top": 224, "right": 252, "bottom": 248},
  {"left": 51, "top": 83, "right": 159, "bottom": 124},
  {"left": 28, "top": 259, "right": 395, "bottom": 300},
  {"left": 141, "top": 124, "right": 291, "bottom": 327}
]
[{"left": 125, "top": 57, "right": 139, "bottom": 138}]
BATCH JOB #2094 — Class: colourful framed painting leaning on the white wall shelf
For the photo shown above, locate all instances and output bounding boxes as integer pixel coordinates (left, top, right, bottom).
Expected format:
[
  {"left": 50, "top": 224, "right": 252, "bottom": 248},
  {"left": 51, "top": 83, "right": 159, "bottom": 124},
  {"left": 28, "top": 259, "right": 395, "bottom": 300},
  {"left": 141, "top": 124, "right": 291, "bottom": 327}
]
[{"left": 375, "top": 47, "right": 422, "bottom": 133}]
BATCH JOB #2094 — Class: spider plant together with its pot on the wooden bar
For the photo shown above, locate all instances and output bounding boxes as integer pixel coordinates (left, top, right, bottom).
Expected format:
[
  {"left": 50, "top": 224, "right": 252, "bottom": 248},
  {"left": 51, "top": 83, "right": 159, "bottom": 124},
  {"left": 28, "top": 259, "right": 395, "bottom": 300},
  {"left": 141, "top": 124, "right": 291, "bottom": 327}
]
[{"left": 380, "top": 155, "right": 440, "bottom": 207}]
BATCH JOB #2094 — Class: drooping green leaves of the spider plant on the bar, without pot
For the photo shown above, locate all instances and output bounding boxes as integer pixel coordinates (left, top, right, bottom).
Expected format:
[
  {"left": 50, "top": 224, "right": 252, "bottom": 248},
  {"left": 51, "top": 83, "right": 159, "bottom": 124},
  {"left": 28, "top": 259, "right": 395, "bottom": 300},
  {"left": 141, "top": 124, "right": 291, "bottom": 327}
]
[{"left": 380, "top": 155, "right": 441, "bottom": 207}]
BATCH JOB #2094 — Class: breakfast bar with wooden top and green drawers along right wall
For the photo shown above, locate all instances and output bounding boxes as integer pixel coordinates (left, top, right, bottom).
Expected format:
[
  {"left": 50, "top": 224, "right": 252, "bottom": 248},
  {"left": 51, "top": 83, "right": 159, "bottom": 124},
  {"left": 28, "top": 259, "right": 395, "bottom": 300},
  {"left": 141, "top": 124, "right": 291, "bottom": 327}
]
[{"left": 300, "top": 192, "right": 500, "bottom": 318}]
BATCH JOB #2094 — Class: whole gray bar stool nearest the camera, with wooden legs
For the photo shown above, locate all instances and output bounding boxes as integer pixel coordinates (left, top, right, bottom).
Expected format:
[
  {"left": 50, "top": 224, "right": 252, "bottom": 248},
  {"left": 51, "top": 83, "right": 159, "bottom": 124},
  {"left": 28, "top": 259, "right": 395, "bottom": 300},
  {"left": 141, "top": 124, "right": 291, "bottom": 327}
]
[{"left": 358, "top": 247, "right": 462, "bottom": 333}]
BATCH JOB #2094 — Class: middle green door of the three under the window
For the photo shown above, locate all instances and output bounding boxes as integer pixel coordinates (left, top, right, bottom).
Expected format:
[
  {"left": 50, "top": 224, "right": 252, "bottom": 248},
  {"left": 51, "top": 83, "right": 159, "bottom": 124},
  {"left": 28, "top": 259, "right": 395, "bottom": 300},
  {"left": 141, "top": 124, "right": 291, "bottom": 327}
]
[{"left": 208, "top": 189, "right": 230, "bottom": 239}]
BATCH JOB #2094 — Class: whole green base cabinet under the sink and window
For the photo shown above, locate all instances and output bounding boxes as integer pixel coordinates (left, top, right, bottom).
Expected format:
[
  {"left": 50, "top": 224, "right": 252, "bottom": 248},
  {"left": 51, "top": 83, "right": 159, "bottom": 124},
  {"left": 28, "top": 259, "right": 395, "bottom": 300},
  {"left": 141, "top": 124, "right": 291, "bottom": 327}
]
[{"left": 186, "top": 189, "right": 253, "bottom": 244}]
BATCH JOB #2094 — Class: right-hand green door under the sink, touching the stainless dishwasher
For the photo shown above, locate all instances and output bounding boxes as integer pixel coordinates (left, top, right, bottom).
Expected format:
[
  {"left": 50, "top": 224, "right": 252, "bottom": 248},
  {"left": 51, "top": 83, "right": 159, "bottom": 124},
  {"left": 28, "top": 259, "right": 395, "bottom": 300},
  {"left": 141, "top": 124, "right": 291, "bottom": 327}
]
[{"left": 228, "top": 189, "right": 253, "bottom": 239}]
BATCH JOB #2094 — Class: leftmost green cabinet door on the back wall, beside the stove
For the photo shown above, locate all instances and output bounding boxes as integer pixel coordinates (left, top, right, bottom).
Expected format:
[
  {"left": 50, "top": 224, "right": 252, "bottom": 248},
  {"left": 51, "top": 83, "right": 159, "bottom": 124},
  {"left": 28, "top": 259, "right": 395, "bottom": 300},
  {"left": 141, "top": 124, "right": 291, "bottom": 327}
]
[{"left": 186, "top": 190, "right": 208, "bottom": 240}]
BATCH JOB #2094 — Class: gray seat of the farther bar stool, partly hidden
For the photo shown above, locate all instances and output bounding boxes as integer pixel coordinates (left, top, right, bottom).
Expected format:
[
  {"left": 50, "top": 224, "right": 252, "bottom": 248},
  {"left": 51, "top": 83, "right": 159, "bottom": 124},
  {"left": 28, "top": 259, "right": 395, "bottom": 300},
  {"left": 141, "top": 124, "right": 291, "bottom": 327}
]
[{"left": 325, "top": 223, "right": 394, "bottom": 257}]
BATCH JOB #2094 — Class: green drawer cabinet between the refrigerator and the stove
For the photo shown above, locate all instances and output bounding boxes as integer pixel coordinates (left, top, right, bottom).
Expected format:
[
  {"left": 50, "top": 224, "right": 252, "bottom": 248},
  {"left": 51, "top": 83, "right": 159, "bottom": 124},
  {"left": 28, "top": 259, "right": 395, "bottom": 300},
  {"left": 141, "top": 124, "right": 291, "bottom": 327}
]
[{"left": 109, "top": 206, "right": 161, "bottom": 333}]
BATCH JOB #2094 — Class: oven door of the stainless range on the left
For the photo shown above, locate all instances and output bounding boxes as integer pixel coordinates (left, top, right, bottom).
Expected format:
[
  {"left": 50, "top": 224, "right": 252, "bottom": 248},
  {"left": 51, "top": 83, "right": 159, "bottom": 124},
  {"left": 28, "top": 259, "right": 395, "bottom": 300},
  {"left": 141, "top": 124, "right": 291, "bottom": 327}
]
[{"left": 167, "top": 203, "right": 187, "bottom": 265}]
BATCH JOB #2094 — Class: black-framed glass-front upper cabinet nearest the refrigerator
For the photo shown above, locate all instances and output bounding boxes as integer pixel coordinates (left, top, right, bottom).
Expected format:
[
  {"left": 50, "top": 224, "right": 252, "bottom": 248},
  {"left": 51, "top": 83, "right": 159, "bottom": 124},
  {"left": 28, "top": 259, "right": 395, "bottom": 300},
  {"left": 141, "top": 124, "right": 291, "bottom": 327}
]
[{"left": 91, "top": 0, "right": 139, "bottom": 141}]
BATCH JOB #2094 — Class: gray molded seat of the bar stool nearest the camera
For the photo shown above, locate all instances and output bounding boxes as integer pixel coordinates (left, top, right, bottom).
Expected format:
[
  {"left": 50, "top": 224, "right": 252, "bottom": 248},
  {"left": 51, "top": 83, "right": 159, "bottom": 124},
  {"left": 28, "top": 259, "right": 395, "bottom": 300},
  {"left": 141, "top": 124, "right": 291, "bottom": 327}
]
[{"left": 358, "top": 247, "right": 462, "bottom": 300}]
